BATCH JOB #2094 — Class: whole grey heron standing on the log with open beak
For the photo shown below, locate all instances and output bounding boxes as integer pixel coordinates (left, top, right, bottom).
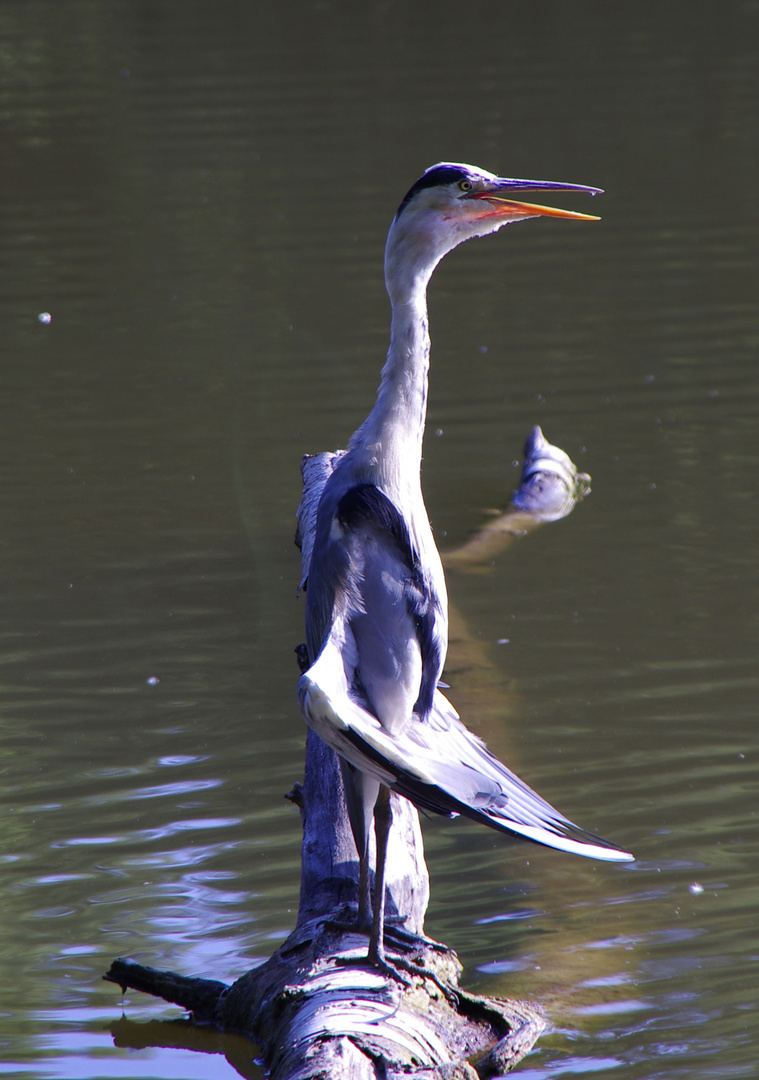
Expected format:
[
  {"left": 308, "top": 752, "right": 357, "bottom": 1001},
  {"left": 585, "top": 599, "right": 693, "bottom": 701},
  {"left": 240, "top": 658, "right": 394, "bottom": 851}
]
[{"left": 298, "top": 162, "right": 633, "bottom": 966}]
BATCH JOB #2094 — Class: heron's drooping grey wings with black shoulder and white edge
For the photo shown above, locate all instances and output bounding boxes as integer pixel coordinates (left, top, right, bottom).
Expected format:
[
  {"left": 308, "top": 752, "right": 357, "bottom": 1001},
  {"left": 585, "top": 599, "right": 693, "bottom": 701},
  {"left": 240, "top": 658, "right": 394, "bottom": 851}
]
[{"left": 298, "top": 462, "right": 633, "bottom": 861}]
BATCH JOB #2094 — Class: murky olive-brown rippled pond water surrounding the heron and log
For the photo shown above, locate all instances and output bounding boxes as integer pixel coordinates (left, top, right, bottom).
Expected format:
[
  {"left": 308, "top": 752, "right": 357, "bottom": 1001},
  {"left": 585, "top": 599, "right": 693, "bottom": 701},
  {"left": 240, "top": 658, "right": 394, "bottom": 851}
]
[{"left": 0, "top": 0, "right": 759, "bottom": 1080}]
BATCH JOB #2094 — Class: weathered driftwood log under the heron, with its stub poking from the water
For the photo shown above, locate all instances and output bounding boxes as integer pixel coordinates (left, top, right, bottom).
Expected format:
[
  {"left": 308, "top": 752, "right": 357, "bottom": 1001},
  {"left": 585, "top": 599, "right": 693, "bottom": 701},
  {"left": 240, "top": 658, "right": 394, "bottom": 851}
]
[{"left": 104, "top": 429, "right": 588, "bottom": 1080}]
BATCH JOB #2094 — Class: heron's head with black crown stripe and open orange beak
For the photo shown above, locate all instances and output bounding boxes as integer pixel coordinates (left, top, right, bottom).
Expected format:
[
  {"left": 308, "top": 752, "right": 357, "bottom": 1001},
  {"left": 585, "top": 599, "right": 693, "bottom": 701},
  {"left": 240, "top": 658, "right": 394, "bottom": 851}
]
[{"left": 385, "top": 162, "right": 601, "bottom": 296}]
